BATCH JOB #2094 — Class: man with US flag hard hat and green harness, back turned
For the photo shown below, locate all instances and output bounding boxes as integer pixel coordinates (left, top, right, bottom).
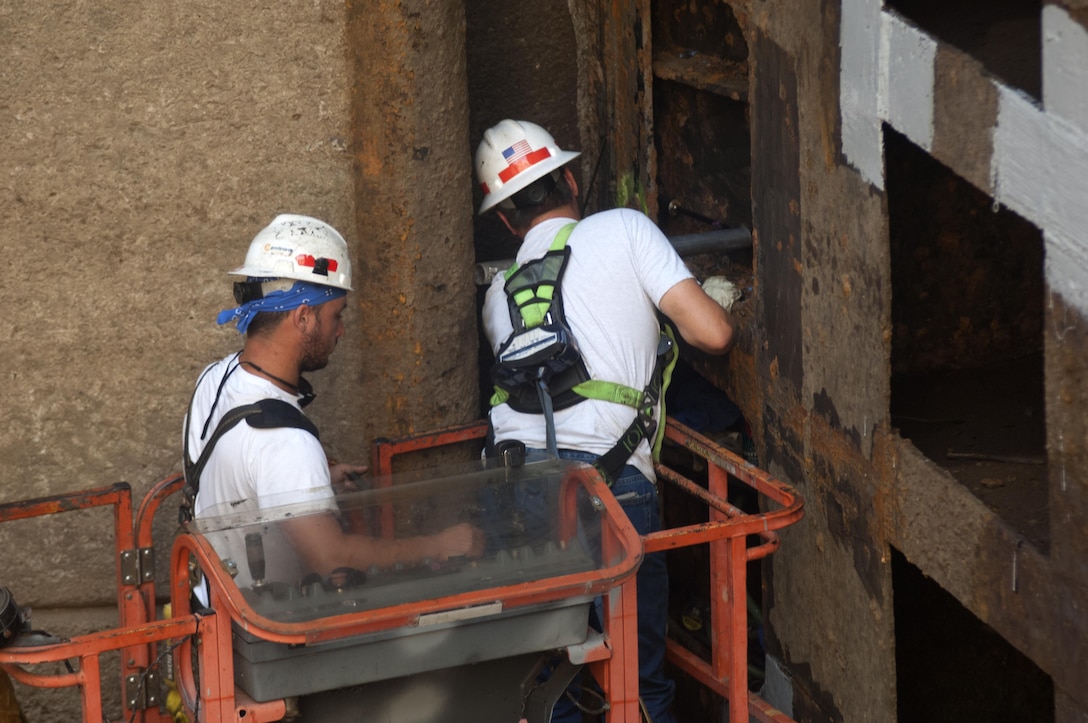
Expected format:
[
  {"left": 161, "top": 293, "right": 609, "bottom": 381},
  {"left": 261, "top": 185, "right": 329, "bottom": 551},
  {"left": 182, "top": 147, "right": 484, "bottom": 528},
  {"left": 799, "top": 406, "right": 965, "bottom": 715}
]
[{"left": 475, "top": 120, "right": 733, "bottom": 723}]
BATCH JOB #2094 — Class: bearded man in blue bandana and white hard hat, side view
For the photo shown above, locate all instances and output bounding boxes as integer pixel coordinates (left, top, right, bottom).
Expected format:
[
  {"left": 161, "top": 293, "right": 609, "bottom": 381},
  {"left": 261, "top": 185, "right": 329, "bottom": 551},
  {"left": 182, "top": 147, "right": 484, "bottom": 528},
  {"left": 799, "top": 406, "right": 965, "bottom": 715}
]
[{"left": 183, "top": 214, "right": 483, "bottom": 585}]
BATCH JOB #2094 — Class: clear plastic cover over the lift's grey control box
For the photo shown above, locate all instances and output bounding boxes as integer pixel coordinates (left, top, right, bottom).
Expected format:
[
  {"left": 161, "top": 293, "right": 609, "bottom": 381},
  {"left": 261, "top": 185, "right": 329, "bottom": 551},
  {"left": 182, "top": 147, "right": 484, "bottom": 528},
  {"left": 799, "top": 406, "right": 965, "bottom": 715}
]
[{"left": 190, "top": 457, "right": 622, "bottom": 622}]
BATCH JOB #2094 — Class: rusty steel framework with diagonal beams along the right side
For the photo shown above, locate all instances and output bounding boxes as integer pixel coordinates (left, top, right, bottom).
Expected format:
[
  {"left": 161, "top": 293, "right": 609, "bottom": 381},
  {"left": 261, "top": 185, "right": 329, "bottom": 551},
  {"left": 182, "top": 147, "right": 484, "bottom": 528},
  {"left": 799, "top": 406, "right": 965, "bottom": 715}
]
[{"left": 739, "top": 2, "right": 1088, "bottom": 721}]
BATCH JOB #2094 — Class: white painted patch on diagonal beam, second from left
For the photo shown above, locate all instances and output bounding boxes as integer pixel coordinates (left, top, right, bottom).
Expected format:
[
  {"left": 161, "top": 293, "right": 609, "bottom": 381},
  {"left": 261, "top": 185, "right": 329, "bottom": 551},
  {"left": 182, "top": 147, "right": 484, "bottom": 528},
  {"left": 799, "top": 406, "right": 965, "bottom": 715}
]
[{"left": 880, "top": 13, "right": 937, "bottom": 151}]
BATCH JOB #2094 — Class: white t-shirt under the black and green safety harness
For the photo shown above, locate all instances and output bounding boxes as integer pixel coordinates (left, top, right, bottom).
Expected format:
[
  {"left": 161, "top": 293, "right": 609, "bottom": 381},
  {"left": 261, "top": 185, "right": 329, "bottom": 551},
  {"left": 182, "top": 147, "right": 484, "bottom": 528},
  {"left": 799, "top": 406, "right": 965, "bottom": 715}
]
[{"left": 483, "top": 209, "right": 692, "bottom": 479}]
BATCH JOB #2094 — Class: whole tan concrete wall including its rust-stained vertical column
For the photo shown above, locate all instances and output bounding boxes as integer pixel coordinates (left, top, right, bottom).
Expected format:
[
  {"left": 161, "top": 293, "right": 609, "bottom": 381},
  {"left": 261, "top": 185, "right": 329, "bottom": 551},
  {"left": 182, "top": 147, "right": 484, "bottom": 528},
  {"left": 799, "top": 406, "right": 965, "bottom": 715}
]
[{"left": 0, "top": 0, "right": 477, "bottom": 721}]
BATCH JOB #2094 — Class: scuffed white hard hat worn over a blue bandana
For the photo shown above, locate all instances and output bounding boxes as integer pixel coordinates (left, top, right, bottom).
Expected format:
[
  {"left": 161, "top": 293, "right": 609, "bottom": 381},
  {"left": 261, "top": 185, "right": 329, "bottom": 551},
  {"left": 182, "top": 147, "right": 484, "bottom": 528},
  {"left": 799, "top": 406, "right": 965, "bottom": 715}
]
[{"left": 228, "top": 213, "right": 351, "bottom": 291}]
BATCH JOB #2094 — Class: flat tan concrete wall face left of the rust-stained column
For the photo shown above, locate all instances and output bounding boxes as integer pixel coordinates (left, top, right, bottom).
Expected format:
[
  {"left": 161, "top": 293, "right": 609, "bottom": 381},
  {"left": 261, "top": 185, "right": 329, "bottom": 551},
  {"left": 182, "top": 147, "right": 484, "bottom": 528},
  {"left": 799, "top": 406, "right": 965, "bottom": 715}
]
[{"left": 0, "top": 2, "right": 362, "bottom": 591}]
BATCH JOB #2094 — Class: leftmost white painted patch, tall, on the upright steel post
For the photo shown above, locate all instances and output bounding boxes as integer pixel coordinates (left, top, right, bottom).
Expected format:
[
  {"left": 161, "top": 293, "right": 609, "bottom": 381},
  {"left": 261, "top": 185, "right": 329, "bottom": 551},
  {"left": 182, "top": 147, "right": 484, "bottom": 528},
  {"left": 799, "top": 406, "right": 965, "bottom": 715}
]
[{"left": 839, "top": 0, "right": 883, "bottom": 189}]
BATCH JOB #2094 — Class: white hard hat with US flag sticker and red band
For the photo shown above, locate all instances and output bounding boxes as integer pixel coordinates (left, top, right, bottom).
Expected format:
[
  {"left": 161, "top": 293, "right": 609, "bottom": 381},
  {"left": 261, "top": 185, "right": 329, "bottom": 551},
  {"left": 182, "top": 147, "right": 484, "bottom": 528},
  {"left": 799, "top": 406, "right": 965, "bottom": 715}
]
[{"left": 475, "top": 120, "right": 581, "bottom": 213}]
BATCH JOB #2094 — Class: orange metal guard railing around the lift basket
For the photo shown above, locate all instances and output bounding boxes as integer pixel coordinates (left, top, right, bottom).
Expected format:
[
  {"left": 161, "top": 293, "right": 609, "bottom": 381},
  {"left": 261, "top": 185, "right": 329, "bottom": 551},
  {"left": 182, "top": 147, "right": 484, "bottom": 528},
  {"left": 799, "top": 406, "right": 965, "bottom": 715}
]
[{"left": 0, "top": 420, "right": 803, "bottom": 723}]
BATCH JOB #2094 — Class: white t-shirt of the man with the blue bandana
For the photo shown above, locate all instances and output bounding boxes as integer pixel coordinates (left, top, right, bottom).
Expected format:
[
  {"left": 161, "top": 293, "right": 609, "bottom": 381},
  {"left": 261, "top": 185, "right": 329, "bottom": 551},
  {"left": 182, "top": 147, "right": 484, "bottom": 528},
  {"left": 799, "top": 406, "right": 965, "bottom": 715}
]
[{"left": 188, "top": 353, "right": 335, "bottom": 587}]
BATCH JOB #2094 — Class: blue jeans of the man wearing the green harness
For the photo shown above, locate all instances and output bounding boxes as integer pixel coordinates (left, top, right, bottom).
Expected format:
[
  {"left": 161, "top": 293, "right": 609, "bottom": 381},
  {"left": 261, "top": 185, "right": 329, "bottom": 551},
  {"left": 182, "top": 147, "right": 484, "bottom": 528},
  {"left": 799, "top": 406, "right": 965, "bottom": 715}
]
[{"left": 522, "top": 449, "right": 676, "bottom": 723}]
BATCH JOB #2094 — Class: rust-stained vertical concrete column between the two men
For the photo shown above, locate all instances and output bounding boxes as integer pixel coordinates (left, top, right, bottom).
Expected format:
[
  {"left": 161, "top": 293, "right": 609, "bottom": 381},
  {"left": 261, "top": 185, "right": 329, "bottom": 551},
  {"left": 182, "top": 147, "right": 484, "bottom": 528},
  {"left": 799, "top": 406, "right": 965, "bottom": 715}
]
[{"left": 348, "top": 1, "right": 477, "bottom": 436}]
